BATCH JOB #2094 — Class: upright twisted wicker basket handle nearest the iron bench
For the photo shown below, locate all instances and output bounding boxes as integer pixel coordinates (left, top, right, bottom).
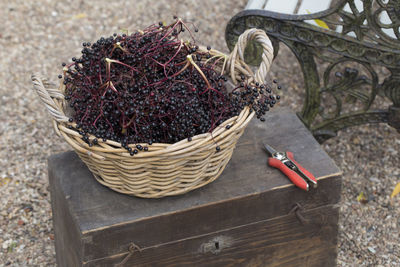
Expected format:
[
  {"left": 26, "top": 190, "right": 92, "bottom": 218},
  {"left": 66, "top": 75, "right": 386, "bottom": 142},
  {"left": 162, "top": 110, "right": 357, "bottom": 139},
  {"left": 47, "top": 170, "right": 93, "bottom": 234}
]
[{"left": 228, "top": 28, "right": 274, "bottom": 84}]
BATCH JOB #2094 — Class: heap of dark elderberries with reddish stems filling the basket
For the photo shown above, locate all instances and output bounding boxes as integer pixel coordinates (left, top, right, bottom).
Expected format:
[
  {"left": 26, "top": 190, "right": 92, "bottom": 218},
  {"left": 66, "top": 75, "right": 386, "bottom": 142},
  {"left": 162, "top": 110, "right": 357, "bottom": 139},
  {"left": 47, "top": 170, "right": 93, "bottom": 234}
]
[{"left": 59, "top": 19, "right": 279, "bottom": 155}]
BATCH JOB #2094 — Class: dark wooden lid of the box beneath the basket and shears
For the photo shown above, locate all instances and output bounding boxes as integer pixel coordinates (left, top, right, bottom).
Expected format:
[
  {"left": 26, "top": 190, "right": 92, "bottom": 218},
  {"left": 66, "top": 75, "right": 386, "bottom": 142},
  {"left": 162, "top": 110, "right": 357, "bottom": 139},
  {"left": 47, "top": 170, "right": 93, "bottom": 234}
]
[{"left": 49, "top": 108, "right": 341, "bottom": 261}]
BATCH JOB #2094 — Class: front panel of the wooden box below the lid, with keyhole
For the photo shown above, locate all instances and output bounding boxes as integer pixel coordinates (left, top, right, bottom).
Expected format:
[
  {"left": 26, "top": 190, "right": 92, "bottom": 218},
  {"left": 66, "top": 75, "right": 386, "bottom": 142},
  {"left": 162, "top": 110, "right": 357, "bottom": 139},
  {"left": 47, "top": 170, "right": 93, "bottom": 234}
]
[{"left": 84, "top": 205, "right": 339, "bottom": 267}]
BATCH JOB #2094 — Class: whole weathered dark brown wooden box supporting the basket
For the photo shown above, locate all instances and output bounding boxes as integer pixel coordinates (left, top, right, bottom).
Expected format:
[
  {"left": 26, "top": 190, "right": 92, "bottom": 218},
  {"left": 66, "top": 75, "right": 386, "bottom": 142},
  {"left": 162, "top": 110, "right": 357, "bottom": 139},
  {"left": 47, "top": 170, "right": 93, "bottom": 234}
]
[{"left": 49, "top": 109, "right": 341, "bottom": 267}]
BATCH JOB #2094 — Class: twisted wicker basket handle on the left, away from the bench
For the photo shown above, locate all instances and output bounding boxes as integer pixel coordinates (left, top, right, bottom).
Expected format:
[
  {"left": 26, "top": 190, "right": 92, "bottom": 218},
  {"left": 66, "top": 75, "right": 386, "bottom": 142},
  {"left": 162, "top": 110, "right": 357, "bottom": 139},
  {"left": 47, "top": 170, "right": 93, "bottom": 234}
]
[{"left": 31, "top": 73, "right": 68, "bottom": 122}]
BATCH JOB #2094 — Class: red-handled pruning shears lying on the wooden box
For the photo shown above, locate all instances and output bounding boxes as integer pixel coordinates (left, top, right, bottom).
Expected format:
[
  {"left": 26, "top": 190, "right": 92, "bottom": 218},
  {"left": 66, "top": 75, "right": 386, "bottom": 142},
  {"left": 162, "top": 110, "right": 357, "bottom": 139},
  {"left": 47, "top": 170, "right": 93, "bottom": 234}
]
[{"left": 264, "top": 144, "right": 317, "bottom": 191}]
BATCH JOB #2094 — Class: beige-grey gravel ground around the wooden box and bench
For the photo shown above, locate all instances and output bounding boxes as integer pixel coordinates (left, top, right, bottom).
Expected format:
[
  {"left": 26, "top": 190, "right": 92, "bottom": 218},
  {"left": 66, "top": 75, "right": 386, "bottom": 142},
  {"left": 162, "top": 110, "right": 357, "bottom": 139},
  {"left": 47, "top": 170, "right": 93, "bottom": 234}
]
[{"left": 0, "top": 0, "right": 400, "bottom": 266}]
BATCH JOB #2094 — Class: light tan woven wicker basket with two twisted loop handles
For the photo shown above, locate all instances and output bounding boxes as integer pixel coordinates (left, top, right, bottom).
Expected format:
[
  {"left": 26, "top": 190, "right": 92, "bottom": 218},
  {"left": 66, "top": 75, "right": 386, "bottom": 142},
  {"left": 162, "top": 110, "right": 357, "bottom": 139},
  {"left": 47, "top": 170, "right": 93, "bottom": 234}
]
[{"left": 32, "top": 29, "right": 273, "bottom": 198}]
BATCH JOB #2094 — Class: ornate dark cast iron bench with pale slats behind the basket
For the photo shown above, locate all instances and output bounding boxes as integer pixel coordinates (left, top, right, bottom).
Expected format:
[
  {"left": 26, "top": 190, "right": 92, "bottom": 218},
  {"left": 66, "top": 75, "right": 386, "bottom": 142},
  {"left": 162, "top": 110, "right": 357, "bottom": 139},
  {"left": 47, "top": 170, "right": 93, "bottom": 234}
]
[{"left": 226, "top": 0, "right": 400, "bottom": 143}]
